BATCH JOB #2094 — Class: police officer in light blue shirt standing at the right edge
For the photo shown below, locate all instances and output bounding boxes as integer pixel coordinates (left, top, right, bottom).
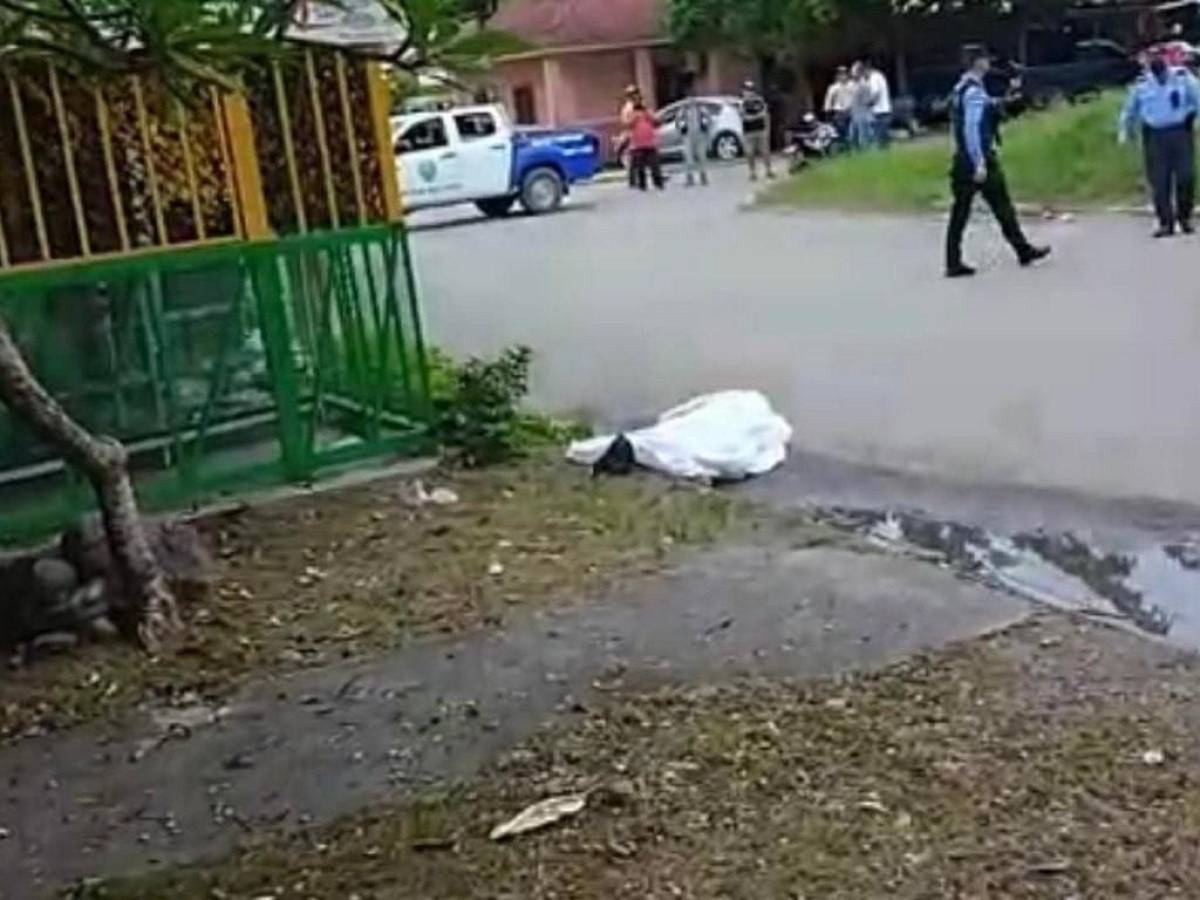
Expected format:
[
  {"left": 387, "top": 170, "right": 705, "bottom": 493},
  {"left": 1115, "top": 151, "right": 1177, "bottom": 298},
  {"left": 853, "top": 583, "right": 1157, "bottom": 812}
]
[{"left": 1117, "top": 53, "right": 1200, "bottom": 238}]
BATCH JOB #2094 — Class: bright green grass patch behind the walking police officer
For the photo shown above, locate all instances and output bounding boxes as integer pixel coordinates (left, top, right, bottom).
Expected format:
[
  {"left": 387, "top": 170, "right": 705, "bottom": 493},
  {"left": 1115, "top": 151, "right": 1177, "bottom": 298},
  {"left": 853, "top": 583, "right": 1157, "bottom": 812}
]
[{"left": 763, "top": 94, "right": 1144, "bottom": 210}]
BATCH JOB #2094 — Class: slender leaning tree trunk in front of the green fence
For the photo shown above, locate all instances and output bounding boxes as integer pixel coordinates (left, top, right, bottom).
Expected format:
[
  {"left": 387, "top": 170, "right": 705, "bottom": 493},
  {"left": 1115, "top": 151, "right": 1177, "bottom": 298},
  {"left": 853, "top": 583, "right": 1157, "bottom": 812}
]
[{"left": 0, "top": 316, "right": 182, "bottom": 652}]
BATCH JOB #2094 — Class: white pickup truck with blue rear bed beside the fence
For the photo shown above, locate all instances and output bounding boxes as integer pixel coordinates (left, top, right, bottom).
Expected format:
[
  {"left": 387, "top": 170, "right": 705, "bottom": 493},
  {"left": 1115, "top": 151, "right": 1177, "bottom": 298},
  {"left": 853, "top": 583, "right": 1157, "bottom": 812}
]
[{"left": 391, "top": 106, "right": 600, "bottom": 216}]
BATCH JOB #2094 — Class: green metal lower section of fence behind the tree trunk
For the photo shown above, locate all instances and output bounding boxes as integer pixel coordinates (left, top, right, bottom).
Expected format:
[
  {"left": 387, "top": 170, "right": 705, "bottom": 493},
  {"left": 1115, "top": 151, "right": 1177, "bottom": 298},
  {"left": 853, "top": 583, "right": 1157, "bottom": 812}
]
[{"left": 0, "top": 226, "right": 430, "bottom": 542}]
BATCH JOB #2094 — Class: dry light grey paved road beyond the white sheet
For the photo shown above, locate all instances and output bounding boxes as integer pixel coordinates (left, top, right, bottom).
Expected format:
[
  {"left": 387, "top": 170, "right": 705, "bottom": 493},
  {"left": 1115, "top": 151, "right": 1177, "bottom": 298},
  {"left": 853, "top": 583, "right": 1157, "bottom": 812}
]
[{"left": 414, "top": 169, "right": 1200, "bottom": 502}]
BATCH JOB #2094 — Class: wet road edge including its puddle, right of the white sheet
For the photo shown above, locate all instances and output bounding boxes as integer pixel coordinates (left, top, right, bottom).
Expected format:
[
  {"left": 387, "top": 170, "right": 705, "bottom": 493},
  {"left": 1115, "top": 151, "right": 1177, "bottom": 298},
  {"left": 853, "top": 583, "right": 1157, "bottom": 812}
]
[{"left": 739, "top": 452, "right": 1200, "bottom": 650}]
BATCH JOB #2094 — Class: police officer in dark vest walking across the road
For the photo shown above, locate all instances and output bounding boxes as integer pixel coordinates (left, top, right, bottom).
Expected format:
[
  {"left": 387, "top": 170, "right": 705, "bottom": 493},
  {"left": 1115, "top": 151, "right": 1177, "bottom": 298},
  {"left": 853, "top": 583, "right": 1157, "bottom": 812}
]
[{"left": 946, "top": 46, "right": 1050, "bottom": 278}]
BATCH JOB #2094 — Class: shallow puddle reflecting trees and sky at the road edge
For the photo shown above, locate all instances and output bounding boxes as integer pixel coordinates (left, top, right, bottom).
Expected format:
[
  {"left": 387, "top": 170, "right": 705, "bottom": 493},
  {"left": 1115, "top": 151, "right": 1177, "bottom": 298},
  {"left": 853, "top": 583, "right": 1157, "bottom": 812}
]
[{"left": 822, "top": 508, "right": 1200, "bottom": 648}]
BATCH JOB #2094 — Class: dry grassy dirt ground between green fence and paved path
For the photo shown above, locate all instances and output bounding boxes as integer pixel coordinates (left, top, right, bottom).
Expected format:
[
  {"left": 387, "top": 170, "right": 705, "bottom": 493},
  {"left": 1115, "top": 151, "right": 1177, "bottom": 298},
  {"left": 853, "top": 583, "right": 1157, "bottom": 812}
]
[{"left": 0, "top": 460, "right": 737, "bottom": 743}]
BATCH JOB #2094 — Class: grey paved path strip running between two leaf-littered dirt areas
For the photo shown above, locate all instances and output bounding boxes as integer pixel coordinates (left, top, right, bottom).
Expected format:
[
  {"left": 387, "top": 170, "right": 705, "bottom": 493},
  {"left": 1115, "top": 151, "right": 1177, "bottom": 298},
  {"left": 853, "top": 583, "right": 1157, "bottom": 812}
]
[{"left": 0, "top": 540, "right": 1030, "bottom": 900}]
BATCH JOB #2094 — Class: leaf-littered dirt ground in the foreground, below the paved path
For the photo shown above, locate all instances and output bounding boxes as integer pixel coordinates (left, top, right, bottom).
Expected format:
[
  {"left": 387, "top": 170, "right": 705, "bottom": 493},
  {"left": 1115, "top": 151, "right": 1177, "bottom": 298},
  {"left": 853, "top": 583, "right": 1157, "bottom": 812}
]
[{"left": 88, "top": 616, "right": 1200, "bottom": 900}]
